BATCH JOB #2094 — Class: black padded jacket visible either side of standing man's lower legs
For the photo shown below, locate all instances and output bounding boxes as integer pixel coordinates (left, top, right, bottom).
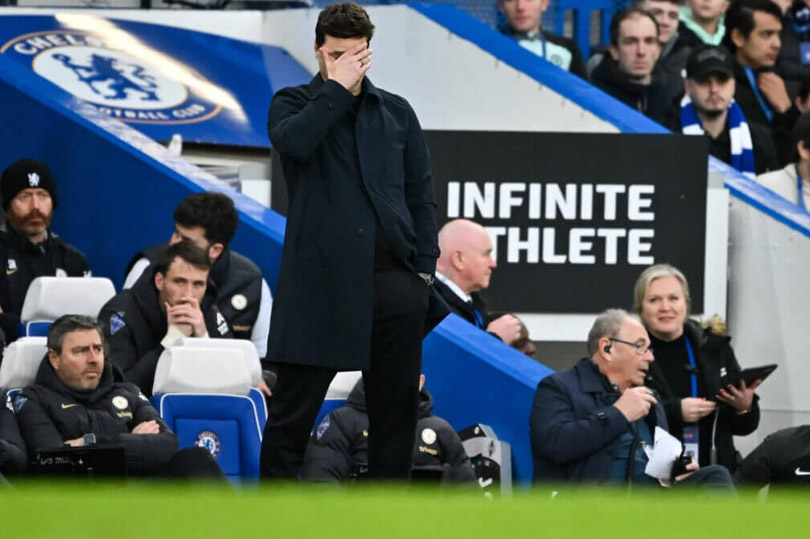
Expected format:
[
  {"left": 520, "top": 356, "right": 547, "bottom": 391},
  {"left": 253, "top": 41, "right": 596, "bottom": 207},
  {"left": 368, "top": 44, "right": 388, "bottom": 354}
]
[{"left": 301, "top": 380, "right": 476, "bottom": 483}]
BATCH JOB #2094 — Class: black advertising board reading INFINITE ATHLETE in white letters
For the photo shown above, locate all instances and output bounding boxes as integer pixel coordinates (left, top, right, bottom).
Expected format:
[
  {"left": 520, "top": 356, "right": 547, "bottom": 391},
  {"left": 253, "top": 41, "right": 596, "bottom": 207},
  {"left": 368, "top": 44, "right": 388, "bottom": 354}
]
[{"left": 272, "top": 131, "right": 708, "bottom": 314}]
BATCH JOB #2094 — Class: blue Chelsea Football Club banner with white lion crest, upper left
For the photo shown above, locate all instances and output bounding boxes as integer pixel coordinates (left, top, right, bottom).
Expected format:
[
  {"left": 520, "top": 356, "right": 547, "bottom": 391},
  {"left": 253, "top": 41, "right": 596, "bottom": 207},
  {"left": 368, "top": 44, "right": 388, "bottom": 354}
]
[{"left": 0, "top": 14, "right": 311, "bottom": 148}]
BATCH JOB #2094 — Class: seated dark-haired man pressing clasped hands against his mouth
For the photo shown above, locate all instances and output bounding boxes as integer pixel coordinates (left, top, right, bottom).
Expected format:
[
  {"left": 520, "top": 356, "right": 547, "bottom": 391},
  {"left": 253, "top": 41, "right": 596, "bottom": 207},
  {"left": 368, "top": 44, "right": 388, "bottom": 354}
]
[{"left": 98, "top": 241, "right": 232, "bottom": 395}]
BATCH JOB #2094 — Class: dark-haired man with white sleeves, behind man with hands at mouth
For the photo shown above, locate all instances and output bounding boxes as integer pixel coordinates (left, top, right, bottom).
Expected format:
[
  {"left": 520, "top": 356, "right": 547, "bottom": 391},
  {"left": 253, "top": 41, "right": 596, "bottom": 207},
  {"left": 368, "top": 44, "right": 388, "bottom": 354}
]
[{"left": 124, "top": 193, "right": 273, "bottom": 359}]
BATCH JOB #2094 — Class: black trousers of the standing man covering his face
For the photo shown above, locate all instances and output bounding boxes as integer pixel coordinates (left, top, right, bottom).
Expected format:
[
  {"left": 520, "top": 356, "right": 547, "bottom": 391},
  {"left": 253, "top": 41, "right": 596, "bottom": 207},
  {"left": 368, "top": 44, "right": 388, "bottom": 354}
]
[{"left": 261, "top": 266, "right": 429, "bottom": 480}]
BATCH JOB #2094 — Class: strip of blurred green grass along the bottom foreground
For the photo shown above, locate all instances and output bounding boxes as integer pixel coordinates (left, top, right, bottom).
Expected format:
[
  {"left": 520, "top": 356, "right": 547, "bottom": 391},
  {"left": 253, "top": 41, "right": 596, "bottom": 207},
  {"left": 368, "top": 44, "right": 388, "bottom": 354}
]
[{"left": 0, "top": 483, "right": 810, "bottom": 539}]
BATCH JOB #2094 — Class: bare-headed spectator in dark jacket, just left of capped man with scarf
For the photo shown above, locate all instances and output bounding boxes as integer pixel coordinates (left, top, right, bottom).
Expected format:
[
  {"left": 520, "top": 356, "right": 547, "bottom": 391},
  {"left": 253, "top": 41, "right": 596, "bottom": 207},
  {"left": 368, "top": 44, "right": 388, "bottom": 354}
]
[{"left": 591, "top": 9, "right": 681, "bottom": 121}]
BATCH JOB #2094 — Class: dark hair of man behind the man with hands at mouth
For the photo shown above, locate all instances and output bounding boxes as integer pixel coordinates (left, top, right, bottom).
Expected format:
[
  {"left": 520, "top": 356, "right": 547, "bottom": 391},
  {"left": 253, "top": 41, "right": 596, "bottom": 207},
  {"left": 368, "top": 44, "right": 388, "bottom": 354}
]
[{"left": 174, "top": 193, "right": 239, "bottom": 247}]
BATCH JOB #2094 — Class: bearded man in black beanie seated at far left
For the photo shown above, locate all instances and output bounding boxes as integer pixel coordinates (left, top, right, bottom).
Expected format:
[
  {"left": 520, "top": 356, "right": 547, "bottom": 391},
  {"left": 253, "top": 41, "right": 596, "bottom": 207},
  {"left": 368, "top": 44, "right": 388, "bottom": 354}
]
[{"left": 0, "top": 159, "right": 90, "bottom": 341}]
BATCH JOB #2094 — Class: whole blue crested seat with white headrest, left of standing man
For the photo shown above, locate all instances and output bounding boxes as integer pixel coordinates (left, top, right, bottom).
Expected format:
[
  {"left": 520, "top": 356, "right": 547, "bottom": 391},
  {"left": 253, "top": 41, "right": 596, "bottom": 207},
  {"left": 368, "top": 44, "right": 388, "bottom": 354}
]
[{"left": 152, "top": 346, "right": 262, "bottom": 482}]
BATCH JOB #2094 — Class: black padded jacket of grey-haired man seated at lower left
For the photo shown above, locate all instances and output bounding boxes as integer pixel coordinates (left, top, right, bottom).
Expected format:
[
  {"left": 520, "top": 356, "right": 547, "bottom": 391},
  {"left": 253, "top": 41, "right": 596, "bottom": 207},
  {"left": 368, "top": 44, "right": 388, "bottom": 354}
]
[{"left": 14, "top": 357, "right": 178, "bottom": 474}]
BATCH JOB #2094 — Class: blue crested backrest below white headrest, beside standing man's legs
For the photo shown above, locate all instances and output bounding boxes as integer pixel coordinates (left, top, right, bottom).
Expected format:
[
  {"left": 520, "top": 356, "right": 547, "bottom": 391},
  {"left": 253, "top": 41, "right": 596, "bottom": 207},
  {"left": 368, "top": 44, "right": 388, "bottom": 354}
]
[{"left": 158, "top": 393, "right": 262, "bottom": 482}]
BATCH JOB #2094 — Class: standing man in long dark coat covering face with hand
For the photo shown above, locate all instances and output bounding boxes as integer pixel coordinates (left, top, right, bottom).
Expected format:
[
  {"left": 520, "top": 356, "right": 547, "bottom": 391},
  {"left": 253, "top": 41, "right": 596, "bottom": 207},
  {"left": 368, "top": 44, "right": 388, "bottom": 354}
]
[{"left": 261, "top": 2, "right": 446, "bottom": 479}]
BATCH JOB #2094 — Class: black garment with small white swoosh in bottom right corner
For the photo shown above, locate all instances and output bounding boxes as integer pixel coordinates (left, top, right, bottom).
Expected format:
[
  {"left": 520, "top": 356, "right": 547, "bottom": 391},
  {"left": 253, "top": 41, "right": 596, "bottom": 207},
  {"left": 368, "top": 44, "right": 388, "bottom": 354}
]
[{"left": 734, "top": 425, "right": 810, "bottom": 486}]
